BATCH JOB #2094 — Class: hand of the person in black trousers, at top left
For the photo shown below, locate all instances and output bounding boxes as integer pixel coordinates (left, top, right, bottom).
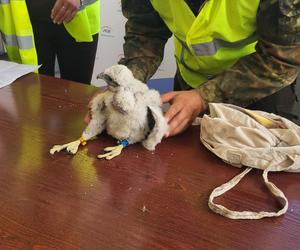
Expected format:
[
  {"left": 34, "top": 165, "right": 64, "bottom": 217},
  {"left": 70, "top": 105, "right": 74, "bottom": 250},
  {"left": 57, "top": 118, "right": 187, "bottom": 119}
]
[{"left": 51, "top": 0, "right": 80, "bottom": 24}]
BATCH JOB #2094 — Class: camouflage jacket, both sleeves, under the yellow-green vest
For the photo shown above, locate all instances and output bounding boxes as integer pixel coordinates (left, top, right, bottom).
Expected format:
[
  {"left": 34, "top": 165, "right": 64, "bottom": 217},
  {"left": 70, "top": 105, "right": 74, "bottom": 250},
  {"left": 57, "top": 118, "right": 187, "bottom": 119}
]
[{"left": 120, "top": 0, "right": 300, "bottom": 106}]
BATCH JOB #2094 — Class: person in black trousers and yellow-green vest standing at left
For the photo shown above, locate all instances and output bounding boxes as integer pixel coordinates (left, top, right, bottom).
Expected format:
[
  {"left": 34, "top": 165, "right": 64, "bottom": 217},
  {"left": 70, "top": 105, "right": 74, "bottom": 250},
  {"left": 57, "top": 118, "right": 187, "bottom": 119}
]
[{"left": 0, "top": 0, "right": 100, "bottom": 84}]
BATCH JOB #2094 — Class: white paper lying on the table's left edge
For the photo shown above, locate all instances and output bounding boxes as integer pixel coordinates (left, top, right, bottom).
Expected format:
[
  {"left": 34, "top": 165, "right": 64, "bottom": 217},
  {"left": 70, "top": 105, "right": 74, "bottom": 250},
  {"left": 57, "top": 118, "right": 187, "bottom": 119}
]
[{"left": 0, "top": 60, "right": 40, "bottom": 88}]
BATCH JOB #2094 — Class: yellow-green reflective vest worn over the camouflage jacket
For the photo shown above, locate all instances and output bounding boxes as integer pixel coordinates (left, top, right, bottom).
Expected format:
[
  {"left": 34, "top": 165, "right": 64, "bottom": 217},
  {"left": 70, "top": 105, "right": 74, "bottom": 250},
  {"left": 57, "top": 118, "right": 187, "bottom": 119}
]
[{"left": 151, "top": 0, "right": 260, "bottom": 88}]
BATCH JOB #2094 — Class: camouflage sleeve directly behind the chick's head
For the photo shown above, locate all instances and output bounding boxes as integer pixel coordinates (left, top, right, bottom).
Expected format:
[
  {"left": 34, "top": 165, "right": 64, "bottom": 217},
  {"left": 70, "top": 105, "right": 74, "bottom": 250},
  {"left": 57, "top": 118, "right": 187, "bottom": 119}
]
[{"left": 119, "top": 0, "right": 172, "bottom": 82}]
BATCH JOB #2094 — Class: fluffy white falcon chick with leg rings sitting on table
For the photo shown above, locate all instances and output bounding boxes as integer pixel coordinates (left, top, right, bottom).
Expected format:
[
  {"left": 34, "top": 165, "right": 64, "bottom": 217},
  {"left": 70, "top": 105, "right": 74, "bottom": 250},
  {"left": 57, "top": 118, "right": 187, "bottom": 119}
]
[{"left": 50, "top": 65, "right": 168, "bottom": 160}]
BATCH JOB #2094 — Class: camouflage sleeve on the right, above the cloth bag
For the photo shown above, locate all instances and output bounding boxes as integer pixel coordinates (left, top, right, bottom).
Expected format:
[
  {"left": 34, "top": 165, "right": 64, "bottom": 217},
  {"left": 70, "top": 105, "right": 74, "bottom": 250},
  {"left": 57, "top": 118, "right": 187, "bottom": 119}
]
[{"left": 198, "top": 0, "right": 300, "bottom": 106}]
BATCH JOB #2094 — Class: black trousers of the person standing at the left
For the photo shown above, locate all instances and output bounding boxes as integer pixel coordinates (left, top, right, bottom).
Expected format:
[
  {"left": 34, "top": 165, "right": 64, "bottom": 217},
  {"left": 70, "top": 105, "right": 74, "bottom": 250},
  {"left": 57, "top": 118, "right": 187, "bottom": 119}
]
[{"left": 31, "top": 20, "right": 98, "bottom": 84}]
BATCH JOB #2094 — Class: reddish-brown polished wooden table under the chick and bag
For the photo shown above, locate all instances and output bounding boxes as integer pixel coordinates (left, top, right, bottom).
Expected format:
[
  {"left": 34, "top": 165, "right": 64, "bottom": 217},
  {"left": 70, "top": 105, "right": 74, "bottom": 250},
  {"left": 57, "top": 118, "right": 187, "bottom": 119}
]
[{"left": 0, "top": 74, "right": 300, "bottom": 250}]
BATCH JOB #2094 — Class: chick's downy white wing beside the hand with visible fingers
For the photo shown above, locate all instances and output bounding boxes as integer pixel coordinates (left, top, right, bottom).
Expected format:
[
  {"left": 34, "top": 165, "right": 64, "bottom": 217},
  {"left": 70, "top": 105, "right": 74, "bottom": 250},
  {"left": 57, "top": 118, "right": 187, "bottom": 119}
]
[{"left": 143, "top": 106, "right": 168, "bottom": 150}]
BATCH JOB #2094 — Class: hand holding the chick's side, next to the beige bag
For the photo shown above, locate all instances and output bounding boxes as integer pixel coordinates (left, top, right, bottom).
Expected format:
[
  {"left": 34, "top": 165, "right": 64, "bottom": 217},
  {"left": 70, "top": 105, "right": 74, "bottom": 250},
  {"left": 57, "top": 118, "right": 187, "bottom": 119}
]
[{"left": 161, "top": 90, "right": 207, "bottom": 137}]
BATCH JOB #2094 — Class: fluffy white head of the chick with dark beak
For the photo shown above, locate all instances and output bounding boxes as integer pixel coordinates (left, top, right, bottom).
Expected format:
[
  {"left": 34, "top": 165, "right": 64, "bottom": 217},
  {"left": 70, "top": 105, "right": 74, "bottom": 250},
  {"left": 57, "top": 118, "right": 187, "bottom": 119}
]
[{"left": 97, "top": 64, "right": 134, "bottom": 91}]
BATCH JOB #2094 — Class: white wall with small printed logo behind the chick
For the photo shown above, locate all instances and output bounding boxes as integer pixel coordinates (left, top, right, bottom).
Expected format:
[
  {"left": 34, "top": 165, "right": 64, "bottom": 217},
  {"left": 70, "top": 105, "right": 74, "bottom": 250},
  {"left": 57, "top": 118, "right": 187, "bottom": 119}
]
[{"left": 92, "top": 0, "right": 175, "bottom": 86}]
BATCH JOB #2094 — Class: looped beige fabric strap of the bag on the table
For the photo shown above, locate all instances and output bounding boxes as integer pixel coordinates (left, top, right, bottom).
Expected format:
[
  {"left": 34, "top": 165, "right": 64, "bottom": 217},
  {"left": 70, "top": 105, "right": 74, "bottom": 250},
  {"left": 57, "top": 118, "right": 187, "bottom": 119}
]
[{"left": 208, "top": 168, "right": 288, "bottom": 219}]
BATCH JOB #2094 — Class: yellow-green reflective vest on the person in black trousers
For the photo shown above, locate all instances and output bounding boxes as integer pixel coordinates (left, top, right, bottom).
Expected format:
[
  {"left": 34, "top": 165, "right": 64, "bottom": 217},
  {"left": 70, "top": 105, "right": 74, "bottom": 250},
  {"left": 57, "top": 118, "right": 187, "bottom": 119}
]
[{"left": 0, "top": 0, "right": 100, "bottom": 65}]
